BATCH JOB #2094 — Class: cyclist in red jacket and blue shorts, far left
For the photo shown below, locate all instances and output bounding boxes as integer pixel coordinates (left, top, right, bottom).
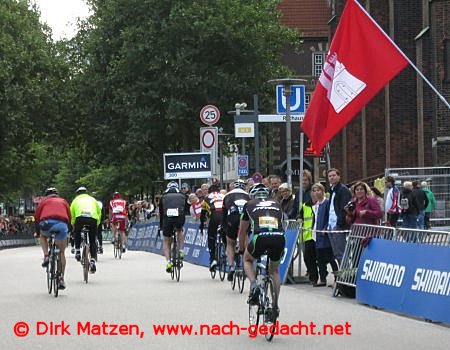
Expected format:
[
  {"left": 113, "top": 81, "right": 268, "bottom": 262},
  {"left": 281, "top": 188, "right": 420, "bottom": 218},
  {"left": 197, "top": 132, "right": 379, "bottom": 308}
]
[{"left": 34, "top": 187, "right": 70, "bottom": 290}]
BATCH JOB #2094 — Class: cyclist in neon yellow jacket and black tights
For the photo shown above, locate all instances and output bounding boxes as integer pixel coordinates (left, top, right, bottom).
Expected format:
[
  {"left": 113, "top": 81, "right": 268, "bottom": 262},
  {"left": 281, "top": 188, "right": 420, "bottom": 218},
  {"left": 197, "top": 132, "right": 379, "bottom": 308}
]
[{"left": 70, "top": 187, "right": 102, "bottom": 273}]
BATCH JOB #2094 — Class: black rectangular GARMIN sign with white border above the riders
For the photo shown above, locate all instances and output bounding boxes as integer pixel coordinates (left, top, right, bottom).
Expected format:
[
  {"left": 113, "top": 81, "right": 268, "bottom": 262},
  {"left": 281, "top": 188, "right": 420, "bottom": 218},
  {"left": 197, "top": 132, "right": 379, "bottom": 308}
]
[{"left": 164, "top": 152, "right": 212, "bottom": 180}]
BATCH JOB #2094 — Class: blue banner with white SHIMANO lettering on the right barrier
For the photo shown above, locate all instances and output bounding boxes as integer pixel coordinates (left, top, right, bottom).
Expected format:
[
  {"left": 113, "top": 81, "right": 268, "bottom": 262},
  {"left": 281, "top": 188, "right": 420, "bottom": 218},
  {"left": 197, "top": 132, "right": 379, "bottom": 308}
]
[{"left": 356, "top": 239, "right": 450, "bottom": 324}]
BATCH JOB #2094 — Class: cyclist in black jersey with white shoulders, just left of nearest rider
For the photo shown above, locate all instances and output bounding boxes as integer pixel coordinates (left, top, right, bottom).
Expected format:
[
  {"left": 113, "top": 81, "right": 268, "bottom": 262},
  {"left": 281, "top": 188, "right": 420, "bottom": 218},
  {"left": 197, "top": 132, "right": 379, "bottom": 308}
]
[{"left": 222, "top": 179, "right": 250, "bottom": 282}]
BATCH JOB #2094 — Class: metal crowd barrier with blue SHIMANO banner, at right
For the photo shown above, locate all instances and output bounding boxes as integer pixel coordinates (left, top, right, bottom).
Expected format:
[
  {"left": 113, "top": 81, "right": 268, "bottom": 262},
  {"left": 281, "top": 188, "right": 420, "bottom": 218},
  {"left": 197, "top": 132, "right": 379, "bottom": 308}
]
[{"left": 333, "top": 224, "right": 450, "bottom": 323}]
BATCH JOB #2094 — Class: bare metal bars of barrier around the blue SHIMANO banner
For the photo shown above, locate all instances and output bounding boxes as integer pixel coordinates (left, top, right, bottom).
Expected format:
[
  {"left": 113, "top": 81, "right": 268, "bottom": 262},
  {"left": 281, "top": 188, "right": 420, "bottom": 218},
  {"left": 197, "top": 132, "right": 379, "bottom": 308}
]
[{"left": 333, "top": 224, "right": 450, "bottom": 296}]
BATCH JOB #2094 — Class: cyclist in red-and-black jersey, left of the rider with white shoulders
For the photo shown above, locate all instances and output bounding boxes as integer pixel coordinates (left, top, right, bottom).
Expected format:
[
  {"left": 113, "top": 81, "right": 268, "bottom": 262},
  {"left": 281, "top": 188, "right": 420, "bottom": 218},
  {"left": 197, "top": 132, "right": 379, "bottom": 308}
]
[{"left": 199, "top": 184, "right": 226, "bottom": 271}]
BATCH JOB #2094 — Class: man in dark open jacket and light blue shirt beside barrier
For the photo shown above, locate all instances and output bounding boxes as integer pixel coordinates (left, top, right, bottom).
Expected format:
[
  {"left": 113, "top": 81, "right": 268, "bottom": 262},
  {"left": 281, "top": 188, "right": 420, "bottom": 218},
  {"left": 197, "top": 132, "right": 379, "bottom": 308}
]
[{"left": 327, "top": 168, "right": 352, "bottom": 264}]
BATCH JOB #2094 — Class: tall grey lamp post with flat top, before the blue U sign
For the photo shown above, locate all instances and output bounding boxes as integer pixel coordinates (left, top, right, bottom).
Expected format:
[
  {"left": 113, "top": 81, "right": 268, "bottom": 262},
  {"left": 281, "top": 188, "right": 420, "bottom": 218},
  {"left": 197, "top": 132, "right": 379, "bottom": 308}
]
[{"left": 269, "top": 78, "right": 306, "bottom": 190}]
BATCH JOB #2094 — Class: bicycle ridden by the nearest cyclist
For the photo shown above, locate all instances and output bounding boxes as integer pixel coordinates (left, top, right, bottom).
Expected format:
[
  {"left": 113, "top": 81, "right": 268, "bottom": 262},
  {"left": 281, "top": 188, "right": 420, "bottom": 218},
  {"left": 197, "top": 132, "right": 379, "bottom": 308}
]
[{"left": 248, "top": 257, "right": 279, "bottom": 342}]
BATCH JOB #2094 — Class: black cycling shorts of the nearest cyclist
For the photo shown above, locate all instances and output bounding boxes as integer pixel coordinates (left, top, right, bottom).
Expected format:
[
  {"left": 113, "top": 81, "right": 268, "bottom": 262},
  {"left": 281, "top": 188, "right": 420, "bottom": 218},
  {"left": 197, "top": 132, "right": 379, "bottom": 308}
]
[{"left": 247, "top": 232, "right": 286, "bottom": 263}]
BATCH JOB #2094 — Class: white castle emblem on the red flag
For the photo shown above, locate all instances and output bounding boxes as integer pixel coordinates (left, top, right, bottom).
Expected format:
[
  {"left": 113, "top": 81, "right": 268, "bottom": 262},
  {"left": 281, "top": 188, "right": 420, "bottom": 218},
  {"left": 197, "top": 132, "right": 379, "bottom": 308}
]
[{"left": 319, "top": 52, "right": 366, "bottom": 113}]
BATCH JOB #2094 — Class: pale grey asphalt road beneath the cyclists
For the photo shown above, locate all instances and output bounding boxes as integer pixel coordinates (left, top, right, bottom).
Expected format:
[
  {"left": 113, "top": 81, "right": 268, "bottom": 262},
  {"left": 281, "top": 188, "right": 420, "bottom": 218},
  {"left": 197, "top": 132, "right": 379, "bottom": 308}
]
[{"left": 0, "top": 244, "right": 450, "bottom": 350}]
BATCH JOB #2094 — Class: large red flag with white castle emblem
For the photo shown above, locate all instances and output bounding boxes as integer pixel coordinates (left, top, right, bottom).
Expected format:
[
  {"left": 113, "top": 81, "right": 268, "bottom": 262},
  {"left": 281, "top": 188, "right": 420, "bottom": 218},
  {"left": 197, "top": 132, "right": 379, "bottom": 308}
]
[{"left": 301, "top": 0, "right": 408, "bottom": 152}]
